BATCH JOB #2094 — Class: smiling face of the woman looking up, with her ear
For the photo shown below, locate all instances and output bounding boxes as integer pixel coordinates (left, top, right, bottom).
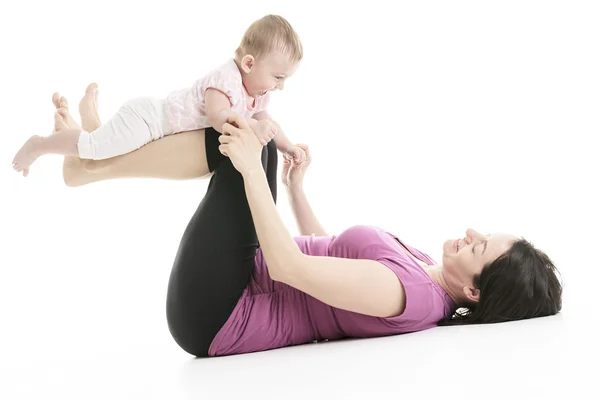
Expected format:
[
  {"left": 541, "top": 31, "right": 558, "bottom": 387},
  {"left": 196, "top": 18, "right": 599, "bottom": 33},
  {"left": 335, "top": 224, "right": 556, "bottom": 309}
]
[{"left": 442, "top": 229, "right": 518, "bottom": 302}]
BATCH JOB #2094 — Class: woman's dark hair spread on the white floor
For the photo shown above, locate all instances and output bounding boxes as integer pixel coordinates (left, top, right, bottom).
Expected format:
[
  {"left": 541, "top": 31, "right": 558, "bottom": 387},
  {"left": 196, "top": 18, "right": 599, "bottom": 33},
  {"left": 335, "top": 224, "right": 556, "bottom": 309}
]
[{"left": 439, "top": 239, "right": 562, "bottom": 325}]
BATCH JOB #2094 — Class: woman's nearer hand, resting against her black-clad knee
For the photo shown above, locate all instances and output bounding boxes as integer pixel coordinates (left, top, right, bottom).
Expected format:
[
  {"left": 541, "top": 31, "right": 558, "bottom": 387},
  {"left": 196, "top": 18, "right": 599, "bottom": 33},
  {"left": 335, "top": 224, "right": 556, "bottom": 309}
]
[{"left": 219, "top": 115, "right": 263, "bottom": 175}]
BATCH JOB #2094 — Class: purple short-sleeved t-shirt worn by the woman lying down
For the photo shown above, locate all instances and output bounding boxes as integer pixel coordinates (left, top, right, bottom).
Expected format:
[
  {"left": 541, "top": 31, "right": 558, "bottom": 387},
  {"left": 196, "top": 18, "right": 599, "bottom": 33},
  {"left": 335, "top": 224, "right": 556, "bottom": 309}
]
[{"left": 209, "top": 226, "right": 454, "bottom": 356}]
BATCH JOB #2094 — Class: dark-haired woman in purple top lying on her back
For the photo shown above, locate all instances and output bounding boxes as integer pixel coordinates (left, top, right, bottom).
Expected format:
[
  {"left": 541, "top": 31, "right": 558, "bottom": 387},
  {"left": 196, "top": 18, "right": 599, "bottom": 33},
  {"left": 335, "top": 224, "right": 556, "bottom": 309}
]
[{"left": 53, "top": 85, "right": 562, "bottom": 356}]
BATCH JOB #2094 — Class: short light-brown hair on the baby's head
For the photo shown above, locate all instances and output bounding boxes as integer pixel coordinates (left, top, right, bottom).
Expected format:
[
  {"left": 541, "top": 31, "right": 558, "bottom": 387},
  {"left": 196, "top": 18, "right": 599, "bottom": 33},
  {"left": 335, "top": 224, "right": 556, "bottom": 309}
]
[{"left": 235, "top": 15, "right": 303, "bottom": 62}]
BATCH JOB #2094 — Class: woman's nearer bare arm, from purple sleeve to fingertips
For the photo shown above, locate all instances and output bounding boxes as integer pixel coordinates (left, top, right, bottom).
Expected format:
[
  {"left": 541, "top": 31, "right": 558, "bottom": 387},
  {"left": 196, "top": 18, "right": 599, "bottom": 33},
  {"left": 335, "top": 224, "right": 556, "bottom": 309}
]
[{"left": 219, "top": 117, "right": 405, "bottom": 317}]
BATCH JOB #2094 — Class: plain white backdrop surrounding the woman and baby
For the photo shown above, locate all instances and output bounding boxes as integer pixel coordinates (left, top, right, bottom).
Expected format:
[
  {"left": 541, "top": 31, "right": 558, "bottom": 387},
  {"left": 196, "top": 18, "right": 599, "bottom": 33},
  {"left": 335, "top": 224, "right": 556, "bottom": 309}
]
[{"left": 0, "top": 0, "right": 600, "bottom": 399}]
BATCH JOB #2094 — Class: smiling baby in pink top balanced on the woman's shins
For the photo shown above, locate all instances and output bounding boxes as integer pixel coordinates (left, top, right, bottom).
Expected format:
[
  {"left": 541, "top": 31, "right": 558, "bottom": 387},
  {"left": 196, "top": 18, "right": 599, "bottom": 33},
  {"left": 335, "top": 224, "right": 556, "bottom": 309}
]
[{"left": 13, "top": 15, "right": 306, "bottom": 176}]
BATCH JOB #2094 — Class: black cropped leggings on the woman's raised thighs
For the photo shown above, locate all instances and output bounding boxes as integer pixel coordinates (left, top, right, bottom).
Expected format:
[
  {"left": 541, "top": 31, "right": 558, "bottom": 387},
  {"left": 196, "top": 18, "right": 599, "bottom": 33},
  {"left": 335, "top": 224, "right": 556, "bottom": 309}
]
[{"left": 167, "top": 129, "right": 277, "bottom": 357}]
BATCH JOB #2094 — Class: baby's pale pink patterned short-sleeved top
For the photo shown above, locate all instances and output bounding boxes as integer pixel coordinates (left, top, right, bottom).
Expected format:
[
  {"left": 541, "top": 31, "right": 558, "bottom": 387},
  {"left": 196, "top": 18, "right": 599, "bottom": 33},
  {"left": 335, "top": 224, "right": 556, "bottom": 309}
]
[{"left": 165, "top": 59, "right": 269, "bottom": 133}]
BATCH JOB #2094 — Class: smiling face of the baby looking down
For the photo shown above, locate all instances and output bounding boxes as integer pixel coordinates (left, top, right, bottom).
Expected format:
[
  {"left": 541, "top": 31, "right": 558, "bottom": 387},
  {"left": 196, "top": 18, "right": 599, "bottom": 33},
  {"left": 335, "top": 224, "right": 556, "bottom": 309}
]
[{"left": 243, "top": 52, "right": 298, "bottom": 97}]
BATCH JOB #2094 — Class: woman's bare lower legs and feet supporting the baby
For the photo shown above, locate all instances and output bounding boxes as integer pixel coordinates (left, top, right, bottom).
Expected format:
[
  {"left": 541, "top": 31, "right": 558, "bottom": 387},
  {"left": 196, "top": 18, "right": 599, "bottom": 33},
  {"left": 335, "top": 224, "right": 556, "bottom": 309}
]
[{"left": 52, "top": 84, "right": 209, "bottom": 187}]
